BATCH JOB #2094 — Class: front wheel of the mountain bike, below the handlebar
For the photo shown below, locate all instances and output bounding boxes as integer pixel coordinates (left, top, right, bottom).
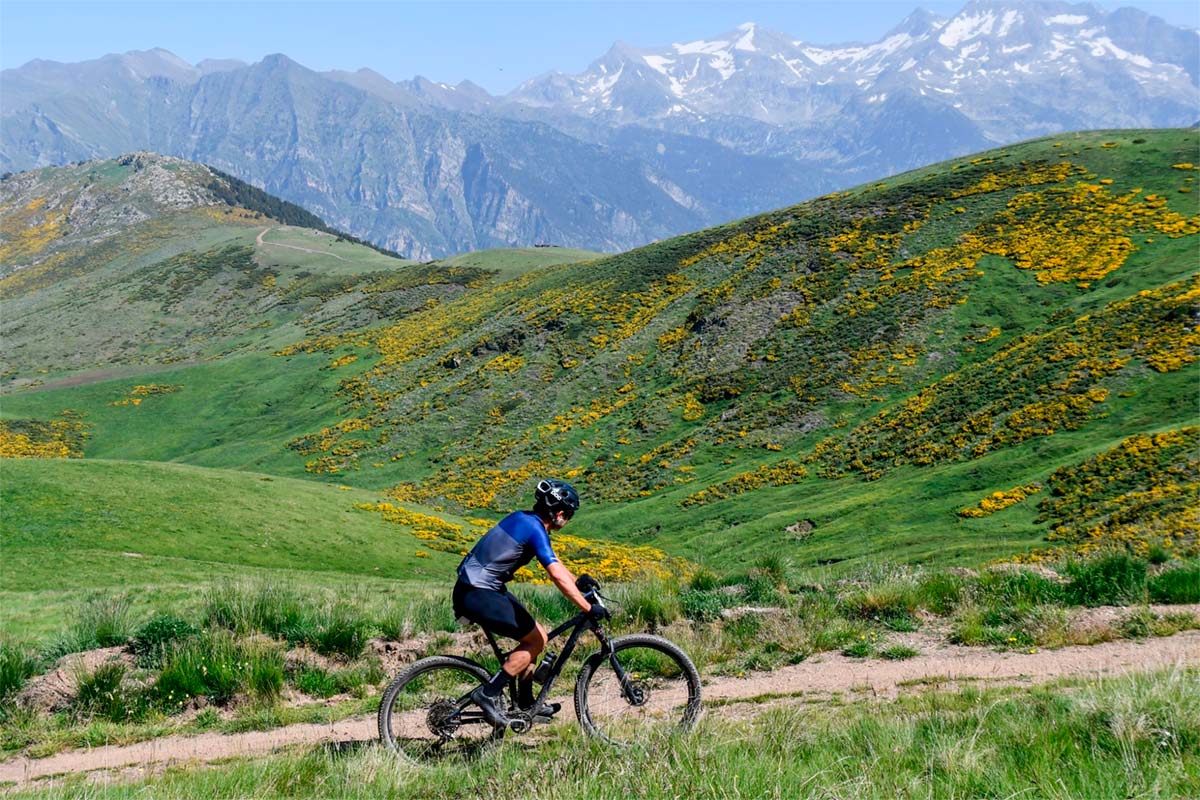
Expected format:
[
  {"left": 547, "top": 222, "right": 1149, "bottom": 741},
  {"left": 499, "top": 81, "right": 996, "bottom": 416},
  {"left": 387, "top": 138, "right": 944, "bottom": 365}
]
[{"left": 575, "top": 633, "right": 700, "bottom": 745}]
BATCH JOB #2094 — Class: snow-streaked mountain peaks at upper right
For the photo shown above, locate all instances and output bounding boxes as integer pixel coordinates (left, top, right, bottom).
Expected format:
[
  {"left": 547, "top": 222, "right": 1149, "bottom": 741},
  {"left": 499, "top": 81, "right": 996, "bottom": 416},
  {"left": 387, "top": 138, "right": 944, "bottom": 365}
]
[{"left": 506, "top": 0, "right": 1200, "bottom": 142}]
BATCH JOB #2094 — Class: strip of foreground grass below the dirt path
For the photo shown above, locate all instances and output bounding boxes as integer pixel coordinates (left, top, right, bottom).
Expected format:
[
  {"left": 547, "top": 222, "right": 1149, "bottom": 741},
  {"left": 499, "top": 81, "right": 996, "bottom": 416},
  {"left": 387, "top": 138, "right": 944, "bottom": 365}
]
[{"left": 7, "top": 670, "right": 1200, "bottom": 800}]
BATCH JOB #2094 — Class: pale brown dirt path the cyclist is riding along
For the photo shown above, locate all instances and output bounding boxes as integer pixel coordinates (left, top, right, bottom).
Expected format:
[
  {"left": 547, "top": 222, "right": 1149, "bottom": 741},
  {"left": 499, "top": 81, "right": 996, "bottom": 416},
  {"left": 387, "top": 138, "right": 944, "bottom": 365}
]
[{"left": 0, "top": 631, "right": 1200, "bottom": 786}]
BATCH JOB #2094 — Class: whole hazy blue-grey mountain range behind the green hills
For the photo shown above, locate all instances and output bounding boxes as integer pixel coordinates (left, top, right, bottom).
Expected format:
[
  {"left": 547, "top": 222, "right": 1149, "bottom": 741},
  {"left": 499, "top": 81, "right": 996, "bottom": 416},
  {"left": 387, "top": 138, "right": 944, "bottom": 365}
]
[{"left": 0, "top": 0, "right": 1200, "bottom": 259}]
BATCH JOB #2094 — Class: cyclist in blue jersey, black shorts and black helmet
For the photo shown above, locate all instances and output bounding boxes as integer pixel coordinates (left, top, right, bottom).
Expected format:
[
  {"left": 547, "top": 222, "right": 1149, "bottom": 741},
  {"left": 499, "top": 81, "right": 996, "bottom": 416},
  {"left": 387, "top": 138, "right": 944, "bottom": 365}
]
[{"left": 454, "top": 479, "right": 608, "bottom": 727}]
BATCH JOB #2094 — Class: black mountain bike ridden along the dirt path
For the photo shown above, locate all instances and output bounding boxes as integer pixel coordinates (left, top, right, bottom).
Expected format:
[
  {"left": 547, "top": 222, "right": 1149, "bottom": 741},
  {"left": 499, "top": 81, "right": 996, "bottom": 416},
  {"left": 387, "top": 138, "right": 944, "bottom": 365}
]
[{"left": 378, "top": 583, "right": 701, "bottom": 760}]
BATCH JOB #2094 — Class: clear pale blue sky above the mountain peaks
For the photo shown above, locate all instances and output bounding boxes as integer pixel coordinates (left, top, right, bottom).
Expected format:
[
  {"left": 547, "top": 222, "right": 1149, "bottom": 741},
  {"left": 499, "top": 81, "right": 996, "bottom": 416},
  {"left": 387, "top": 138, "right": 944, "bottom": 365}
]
[{"left": 7, "top": 0, "right": 1200, "bottom": 92}]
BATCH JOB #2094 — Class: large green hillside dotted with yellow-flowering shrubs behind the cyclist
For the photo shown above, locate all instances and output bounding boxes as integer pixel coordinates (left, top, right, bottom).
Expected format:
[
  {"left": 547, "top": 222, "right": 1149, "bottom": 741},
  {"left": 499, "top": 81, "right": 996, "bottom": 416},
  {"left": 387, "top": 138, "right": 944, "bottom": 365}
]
[{"left": 4, "top": 131, "right": 1200, "bottom": 585}]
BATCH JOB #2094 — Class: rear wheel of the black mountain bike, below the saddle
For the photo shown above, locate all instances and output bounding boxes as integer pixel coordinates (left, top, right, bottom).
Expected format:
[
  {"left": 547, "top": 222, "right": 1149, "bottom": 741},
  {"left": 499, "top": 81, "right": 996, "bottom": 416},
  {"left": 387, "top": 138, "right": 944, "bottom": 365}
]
[{"left": 378, "top": 656, "right": 504, "bottom": 762}]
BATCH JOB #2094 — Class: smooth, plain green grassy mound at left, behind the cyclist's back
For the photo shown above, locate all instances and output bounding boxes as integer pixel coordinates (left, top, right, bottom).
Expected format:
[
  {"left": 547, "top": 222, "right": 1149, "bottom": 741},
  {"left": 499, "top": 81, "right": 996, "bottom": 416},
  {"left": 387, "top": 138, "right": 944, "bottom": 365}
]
[{"left": 0, "top": 459, "right": 457, "bottom": 636}]
